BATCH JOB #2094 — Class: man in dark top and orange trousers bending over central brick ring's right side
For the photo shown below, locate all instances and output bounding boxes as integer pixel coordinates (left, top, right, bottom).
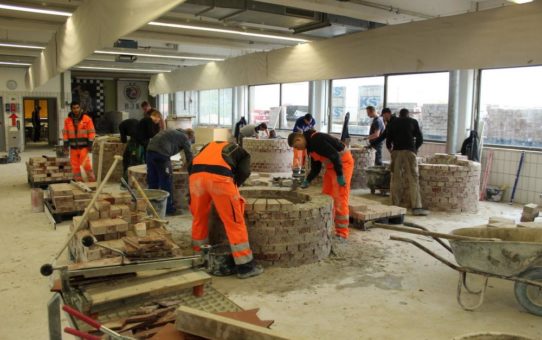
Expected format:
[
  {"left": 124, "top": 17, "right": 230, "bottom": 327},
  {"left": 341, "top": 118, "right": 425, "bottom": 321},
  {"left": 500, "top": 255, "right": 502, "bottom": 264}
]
[{"left": 288, "top": 129, "right": 354, "bottom": 241}]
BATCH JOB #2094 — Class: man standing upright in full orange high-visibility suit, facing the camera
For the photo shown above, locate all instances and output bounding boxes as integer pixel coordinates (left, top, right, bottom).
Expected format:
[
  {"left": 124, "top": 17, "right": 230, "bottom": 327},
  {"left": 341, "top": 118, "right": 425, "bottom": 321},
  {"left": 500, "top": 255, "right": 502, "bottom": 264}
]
[{"left": 62, "top": 101, "right": 96, "bottom": 182}]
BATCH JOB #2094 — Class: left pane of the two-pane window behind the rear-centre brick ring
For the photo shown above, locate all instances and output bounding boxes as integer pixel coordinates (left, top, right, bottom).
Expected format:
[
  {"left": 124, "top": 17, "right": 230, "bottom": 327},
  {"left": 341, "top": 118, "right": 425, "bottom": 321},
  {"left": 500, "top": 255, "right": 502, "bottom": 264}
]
[{"left": 249, "top": 84, "right": 280, "bottom": 124}]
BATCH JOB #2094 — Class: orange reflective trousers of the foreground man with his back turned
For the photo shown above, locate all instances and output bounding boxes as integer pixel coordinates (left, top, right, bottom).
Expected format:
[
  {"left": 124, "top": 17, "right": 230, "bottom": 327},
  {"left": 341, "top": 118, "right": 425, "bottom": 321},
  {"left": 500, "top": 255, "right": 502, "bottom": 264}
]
[{"left": 189, "top": 172, "right": 253, "bottom": 265}]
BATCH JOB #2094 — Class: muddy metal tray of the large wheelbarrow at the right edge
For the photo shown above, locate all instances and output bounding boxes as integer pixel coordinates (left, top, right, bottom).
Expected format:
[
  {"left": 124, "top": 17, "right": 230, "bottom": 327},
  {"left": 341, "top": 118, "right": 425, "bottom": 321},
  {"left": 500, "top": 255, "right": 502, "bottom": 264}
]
[{"left": 449, "top": 227, "right": 542, "bottom": 276}]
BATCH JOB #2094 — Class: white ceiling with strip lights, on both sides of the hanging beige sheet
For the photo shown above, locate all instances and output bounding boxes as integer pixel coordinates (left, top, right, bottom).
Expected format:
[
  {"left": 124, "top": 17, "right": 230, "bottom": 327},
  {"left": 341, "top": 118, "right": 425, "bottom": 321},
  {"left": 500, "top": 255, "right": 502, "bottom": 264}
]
[{"left": 0, "top": 0, "right": 524, "bottom": 78}]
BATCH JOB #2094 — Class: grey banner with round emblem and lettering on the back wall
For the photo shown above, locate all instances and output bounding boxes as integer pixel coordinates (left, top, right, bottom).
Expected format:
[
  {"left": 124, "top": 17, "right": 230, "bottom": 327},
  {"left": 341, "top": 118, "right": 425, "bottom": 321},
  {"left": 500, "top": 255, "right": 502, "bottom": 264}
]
[{"left": 117, "top": 80, "right": 149, "bottom": 119}]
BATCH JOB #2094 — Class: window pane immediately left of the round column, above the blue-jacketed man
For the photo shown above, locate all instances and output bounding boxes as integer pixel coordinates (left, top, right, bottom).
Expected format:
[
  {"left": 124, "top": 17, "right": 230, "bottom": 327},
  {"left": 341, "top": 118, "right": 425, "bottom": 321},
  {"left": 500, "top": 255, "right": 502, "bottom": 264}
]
[{"left": 280, "top": 82, "right": 309, "bottom": 129}]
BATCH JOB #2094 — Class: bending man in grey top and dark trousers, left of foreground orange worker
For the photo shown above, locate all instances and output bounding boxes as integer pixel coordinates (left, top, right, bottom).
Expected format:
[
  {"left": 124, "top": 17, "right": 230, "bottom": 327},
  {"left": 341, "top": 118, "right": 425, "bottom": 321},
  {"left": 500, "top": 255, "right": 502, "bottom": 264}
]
[{"left": 147, "top": 129, "right": 194, "bottom": 215}]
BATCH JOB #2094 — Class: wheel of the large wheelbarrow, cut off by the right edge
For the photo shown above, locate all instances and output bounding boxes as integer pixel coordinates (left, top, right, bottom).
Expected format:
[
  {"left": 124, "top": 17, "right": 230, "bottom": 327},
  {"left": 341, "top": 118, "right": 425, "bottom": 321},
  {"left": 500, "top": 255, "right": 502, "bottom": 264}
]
[{"left": 514, "top": 267, "right": 542, "bottom": 316}]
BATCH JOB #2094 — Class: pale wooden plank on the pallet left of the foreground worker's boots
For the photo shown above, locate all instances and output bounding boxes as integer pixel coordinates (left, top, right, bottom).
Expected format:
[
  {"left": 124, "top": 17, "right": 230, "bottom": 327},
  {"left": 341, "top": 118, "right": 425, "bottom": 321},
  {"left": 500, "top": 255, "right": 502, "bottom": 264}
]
[{"left": 85, "top": 270, "right": 211, "bottom": 306}]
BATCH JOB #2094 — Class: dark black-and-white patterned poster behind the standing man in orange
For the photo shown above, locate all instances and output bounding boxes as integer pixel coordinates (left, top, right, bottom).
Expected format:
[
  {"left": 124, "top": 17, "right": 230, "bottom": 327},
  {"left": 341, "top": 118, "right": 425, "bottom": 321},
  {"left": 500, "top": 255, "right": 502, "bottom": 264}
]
[{"left": 72, "top": 78, "right": 104, "bottom": 119}]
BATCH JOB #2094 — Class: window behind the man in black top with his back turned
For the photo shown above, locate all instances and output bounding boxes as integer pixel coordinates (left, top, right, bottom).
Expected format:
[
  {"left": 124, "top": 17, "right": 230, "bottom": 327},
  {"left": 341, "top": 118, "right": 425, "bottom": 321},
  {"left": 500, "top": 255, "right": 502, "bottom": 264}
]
[{"left": 387, "top": 72, "right": 450, "bottom": 141}]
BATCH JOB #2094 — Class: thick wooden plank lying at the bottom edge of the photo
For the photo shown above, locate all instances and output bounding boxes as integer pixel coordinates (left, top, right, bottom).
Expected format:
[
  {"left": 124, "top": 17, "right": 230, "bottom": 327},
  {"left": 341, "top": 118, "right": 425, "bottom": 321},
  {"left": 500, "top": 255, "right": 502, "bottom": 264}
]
[{"left": 175, "top": 306, "right": 287, "bottom": 340}]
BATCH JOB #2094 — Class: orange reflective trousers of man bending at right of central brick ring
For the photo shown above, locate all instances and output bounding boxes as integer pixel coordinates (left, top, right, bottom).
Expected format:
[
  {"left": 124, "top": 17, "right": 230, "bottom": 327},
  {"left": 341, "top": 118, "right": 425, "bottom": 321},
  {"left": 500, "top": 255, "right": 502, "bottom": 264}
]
[{"left": 322, "top": 151, "right": 354, "bottom": 238}]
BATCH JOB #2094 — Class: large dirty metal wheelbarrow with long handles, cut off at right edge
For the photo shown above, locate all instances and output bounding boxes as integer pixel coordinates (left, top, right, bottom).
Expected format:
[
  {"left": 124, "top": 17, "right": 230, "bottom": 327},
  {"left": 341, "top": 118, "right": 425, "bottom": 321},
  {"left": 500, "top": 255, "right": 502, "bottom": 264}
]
[{"left": 371, "top": 223, "right": 542, "bottom": 316}]
